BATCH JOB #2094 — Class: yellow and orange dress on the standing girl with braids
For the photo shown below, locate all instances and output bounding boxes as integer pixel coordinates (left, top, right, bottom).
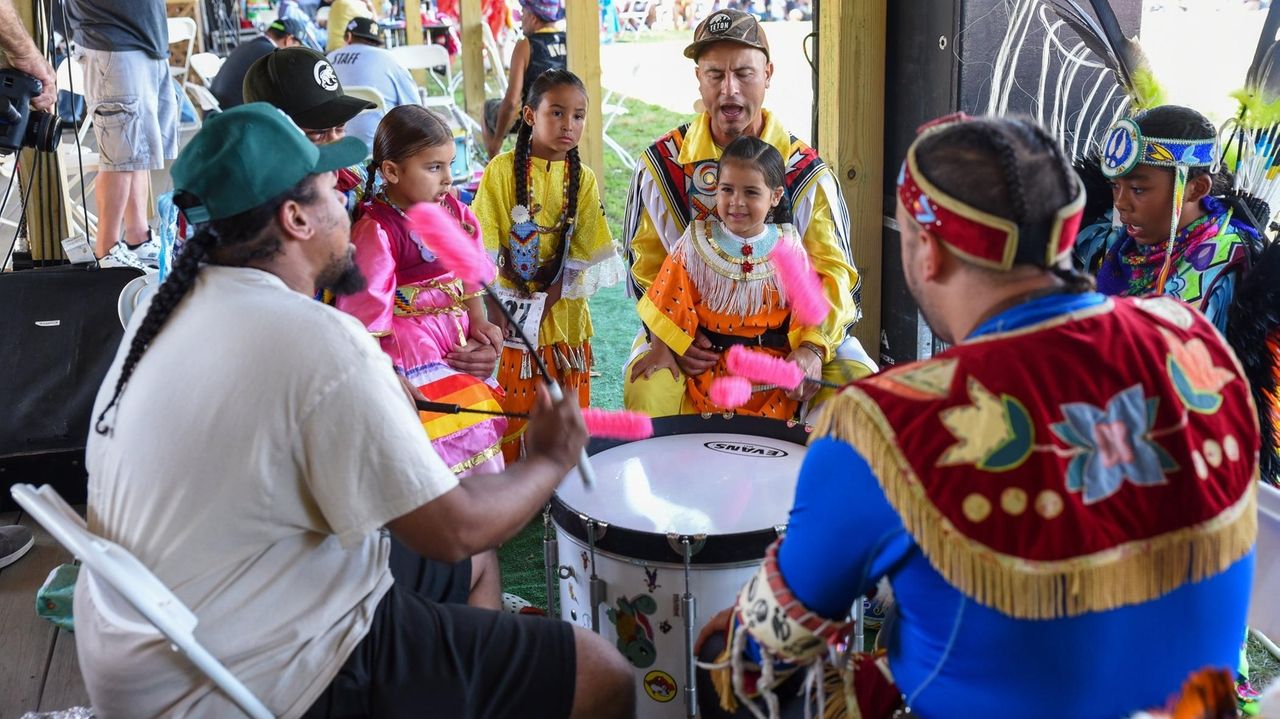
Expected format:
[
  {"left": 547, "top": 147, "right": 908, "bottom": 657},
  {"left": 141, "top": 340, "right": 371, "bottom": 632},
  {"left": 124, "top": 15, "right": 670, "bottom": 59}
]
[{"left": 471, "top": 152, "right": 626, "bottom": 462}]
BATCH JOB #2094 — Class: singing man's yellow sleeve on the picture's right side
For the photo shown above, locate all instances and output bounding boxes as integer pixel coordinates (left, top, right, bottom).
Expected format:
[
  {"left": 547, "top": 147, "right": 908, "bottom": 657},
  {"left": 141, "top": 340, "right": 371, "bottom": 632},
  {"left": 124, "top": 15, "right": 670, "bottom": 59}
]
[{"left": 791, "top": 188, "right": 859, "bottom": 361}]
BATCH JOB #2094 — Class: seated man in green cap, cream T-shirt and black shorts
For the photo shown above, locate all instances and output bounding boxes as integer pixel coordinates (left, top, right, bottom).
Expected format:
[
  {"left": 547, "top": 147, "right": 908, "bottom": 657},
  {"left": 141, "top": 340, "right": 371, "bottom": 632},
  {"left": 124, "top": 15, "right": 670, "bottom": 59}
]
[{"left": 76, "top": 102, "right": 634, "bottom": 718}]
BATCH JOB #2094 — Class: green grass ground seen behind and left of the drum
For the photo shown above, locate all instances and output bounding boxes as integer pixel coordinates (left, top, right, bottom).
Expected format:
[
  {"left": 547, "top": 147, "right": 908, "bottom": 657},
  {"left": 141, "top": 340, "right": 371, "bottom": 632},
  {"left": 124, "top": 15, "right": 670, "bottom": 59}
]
[{"left": 498, "top": 100, "right": 686, "bottom": 606}]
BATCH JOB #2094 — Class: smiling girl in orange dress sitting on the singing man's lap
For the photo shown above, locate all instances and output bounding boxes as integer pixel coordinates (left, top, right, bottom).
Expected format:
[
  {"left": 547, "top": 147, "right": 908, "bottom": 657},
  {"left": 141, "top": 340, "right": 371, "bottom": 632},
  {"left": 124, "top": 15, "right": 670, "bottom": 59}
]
[{"left": 631, "top": 136, "right": 824, "bottom": 420}]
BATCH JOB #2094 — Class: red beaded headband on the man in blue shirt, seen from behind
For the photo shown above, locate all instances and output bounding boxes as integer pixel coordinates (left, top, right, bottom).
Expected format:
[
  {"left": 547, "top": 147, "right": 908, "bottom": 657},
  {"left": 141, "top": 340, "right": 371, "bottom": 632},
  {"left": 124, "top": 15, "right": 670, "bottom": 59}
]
[{"left": 897, "top": 116, "right": 1084, "bottom": 270}]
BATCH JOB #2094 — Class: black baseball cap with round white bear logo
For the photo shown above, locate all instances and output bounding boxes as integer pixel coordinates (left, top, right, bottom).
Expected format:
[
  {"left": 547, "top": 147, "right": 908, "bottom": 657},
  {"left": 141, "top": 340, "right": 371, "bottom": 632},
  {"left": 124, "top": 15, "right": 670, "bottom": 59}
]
[{"left": 243, "top": 47, "right": 375, "bottom": 129}]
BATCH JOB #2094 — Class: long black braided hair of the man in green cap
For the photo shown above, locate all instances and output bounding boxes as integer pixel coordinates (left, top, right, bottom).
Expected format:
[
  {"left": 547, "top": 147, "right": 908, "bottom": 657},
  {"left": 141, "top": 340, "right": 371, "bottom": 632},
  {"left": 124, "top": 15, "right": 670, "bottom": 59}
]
[{"left": 93, "top": 175, "right": 319, "bottom": 435}]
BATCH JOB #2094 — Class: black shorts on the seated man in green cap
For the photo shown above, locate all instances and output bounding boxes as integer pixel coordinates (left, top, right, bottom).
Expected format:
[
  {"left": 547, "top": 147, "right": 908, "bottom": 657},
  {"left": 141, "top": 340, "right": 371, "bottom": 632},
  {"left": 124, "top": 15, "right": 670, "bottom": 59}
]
[{"left": 303, "top": 586, "right": 576, "bottom": 719}]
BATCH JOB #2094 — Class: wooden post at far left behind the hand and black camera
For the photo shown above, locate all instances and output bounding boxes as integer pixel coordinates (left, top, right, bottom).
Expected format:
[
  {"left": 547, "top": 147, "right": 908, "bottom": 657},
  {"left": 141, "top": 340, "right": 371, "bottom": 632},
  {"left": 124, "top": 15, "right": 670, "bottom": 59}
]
[{"left": 9, "top": 0, "right": 68, "bottom": 262}]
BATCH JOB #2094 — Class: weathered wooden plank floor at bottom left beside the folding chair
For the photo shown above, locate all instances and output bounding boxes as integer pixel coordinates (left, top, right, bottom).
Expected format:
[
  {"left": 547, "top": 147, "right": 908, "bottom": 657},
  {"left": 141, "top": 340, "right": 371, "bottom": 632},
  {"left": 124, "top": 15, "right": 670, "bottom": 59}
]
[{"left": 0, "top": 512, "right": 88, "bottom": 719}]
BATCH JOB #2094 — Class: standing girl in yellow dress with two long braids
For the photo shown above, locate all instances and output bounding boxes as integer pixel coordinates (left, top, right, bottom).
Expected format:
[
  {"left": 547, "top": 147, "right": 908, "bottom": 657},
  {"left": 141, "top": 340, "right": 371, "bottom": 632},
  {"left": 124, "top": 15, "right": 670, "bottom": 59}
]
[{"left": 474, "top": 69, "right": 625, "bottom": 461}]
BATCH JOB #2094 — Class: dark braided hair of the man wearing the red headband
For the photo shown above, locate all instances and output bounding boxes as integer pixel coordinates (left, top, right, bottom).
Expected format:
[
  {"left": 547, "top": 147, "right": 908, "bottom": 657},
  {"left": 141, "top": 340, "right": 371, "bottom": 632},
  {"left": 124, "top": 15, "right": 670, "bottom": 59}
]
[{"left": 915, "top": 118, "right": 1093, "bottom": 292}]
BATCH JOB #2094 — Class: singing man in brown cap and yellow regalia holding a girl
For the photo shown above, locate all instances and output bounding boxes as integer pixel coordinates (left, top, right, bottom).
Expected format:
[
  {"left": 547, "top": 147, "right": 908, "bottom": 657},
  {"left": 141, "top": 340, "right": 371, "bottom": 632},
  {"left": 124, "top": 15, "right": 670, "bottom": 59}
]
[{"left": 622, "top": 10, "right": 876, "bottom": 416}]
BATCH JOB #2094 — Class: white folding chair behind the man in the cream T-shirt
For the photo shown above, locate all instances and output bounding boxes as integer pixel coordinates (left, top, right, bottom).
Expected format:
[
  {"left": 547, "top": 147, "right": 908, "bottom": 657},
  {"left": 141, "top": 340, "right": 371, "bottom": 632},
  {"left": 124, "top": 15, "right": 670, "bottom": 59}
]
[{"left": 9, "top": 485, "right": 271, "bottom": 719}]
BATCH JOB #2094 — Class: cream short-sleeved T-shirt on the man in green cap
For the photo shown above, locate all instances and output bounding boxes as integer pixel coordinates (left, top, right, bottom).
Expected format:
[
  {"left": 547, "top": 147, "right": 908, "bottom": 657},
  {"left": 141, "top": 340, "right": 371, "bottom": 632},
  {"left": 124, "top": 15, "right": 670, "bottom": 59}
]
[{"left": 74, "top": 266, "right": 457, "bottom": 719}]
